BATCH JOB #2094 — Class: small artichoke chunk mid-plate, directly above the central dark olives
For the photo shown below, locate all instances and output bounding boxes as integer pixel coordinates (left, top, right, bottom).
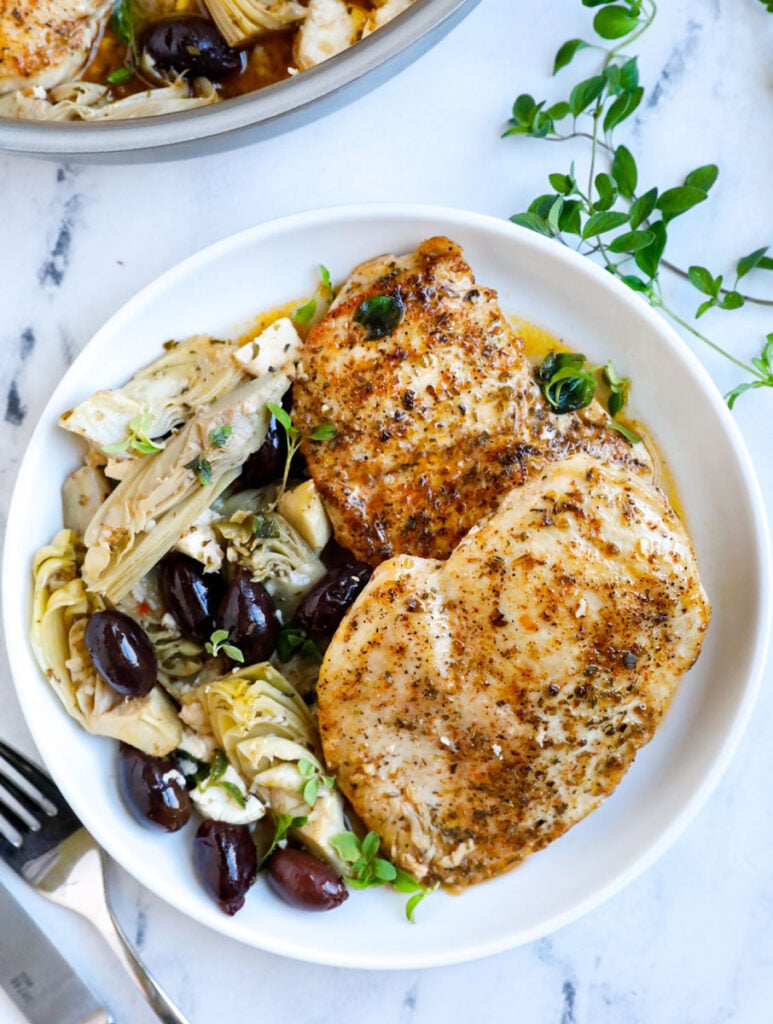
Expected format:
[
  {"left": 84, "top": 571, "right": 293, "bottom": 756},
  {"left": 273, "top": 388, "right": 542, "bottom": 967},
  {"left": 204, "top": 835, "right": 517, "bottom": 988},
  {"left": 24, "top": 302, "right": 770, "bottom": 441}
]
[{"left": 215, "top": 509, "right": 326, "bottom": 622}]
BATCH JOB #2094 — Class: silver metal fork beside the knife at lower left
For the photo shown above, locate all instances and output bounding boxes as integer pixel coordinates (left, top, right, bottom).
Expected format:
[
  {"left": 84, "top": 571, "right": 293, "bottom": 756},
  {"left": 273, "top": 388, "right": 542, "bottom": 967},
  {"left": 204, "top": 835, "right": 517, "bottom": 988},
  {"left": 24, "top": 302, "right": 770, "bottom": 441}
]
[{"left": 0, "top": 741, "right": 188, "bottom": 1024}]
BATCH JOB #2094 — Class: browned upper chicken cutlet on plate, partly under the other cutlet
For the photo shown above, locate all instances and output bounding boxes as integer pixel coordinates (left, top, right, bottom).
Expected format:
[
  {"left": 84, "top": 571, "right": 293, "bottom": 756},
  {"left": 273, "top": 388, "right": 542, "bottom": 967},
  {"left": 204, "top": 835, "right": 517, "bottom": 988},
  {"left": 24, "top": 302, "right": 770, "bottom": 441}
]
[{"left": 293, "top": 238, "right": 649, "bottom": 564}]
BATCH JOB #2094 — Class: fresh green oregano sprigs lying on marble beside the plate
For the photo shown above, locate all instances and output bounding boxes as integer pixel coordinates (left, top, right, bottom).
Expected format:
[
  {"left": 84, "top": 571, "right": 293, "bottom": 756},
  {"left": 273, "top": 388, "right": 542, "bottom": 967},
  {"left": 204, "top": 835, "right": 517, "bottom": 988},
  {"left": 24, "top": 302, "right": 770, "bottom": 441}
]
[{"left": 505, "top": 0, "right": 773, "bottom": 403}]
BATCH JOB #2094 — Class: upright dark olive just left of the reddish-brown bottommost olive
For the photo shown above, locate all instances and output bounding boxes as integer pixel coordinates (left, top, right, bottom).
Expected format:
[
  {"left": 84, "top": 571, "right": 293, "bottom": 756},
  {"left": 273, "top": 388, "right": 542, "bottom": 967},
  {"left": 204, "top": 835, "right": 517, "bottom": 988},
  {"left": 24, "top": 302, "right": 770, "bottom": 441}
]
[{"left": 194, "top": 818, "right": 258, "bottom": 913}]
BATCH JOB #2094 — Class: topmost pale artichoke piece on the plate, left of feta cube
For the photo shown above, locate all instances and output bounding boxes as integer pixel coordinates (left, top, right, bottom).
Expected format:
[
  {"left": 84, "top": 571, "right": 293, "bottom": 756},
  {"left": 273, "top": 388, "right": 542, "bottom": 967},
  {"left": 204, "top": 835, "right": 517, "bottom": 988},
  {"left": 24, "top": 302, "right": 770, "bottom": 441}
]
[{"left": 59, "top": 334, "right": 243, "bottom": 450}]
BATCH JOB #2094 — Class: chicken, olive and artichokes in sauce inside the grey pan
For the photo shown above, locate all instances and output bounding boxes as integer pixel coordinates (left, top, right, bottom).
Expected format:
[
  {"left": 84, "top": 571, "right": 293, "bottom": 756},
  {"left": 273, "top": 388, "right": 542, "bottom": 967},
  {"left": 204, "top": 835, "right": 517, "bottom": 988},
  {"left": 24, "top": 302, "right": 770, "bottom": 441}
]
[{"left": 0, "top": 0, "right": 414, "bottom": 121}]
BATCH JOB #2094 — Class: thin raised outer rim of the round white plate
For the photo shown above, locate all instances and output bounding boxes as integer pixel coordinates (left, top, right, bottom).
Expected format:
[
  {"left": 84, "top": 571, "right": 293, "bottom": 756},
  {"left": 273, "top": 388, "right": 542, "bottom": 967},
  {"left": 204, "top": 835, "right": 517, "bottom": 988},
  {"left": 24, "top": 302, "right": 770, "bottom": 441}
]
[{"left": 2, "top": 203, "right": 773, "bottom": 970}]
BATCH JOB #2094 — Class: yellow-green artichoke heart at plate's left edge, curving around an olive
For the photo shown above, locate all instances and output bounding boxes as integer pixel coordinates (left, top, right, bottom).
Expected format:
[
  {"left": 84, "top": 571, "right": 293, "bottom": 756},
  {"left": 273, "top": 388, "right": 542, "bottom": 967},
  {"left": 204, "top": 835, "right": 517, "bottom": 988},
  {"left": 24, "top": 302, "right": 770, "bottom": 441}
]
[{"left": 31, "top": 529, "right": 181, "bottom": 757}]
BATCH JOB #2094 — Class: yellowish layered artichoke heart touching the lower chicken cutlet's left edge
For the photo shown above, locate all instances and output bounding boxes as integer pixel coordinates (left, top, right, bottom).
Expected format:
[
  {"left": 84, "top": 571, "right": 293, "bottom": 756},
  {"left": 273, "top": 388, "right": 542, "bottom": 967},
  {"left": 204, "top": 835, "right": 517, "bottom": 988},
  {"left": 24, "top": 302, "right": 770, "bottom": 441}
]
[{"left": 196, "top": 664, "right": 346, "bottom": 874}]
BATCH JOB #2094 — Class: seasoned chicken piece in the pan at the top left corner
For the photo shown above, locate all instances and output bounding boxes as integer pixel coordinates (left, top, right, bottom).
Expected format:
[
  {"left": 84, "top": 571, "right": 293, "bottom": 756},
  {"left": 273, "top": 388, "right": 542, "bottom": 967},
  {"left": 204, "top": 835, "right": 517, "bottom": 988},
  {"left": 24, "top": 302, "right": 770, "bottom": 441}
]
[{"left": 0, "top": 0, "right": 112, "bottom": 94}]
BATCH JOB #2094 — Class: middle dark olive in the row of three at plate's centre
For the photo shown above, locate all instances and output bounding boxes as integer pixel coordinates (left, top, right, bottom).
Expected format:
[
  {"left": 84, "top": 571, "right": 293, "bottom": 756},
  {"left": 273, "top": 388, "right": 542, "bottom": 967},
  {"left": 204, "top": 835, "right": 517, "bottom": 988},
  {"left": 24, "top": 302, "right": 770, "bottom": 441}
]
[{"left": 217, "top": 568, "right": 280, "bottom": 665}]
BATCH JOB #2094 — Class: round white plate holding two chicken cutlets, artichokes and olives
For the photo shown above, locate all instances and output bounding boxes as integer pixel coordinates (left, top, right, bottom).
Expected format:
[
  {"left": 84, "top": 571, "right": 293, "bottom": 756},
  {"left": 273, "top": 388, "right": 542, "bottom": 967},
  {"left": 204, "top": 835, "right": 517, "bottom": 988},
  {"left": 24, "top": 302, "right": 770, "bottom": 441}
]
[{"left": 3, "top": 206, "right": 770, "bottom": 968}]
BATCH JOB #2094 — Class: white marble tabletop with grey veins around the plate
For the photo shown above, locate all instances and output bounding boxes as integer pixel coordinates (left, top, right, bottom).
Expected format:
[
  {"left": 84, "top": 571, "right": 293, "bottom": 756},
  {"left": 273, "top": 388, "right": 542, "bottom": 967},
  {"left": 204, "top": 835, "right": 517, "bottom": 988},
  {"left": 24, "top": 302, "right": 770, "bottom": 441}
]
[{"left": 0, "top": 0, "right": 773, "bottom": 1024}]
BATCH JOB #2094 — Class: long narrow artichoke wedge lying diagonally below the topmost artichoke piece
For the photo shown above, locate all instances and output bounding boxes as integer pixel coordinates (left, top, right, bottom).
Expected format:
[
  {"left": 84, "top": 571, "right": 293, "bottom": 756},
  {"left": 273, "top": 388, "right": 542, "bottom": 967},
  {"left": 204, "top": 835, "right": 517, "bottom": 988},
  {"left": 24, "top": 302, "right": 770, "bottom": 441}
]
[{"left": 83, "top": 371, "right": 290, "bottom": 602}]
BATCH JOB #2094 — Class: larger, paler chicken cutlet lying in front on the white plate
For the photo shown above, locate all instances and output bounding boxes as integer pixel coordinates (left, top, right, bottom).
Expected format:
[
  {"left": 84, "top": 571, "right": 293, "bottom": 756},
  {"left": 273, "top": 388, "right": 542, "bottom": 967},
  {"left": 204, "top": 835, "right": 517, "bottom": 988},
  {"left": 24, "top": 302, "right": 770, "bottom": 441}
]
[{"left": 317, "top": 453, "right": 710, "bottom": 888}]
